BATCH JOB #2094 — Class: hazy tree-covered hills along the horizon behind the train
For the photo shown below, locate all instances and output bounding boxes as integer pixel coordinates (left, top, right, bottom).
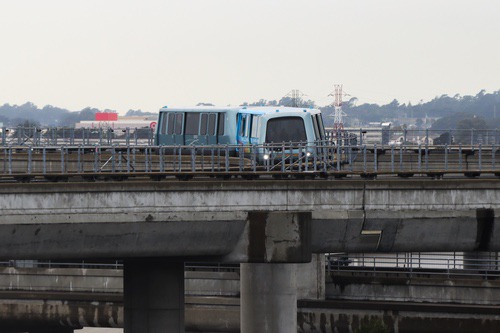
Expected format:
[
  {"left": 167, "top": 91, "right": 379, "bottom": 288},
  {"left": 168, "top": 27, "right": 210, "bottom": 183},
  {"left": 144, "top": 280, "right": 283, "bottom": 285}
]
[{"left": 0, "top": 90, "right": 500, "bottom": 130}]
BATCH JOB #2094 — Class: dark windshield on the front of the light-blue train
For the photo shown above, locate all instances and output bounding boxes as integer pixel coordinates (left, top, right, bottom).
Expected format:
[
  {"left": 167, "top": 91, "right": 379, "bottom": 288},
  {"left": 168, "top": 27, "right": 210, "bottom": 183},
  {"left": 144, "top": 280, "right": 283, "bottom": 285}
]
[{"left": 266, "top": 117, "right": 307, "bottom": 143}]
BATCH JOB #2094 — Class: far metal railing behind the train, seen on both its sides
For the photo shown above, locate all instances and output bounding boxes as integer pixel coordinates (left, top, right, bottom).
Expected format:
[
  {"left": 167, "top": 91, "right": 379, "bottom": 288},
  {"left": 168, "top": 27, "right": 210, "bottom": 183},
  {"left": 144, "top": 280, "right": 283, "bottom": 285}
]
[{"left": 0, "top": 126, "right": 500, "bottom": 147}]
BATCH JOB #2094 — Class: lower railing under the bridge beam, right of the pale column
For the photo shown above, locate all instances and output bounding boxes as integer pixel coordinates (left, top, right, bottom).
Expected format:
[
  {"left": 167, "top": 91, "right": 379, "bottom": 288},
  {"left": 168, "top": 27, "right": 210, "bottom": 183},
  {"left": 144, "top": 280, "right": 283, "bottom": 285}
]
[{"left": 326, "top": 252, "right": 500, "bottom": 279}]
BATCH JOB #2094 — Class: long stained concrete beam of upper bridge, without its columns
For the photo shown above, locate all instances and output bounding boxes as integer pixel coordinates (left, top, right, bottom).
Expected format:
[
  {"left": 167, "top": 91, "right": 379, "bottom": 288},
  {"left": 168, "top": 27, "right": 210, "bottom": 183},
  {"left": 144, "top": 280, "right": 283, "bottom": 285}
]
[{"left": 0, "top": 179, "right": 500, "bottom": 262}]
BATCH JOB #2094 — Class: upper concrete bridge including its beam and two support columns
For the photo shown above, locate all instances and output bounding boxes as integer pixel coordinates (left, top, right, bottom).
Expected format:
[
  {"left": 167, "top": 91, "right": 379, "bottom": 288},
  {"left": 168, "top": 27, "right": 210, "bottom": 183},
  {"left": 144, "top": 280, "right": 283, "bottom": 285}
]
[{"left": 0, "top": 179, "right": 500, "bottom": 333}]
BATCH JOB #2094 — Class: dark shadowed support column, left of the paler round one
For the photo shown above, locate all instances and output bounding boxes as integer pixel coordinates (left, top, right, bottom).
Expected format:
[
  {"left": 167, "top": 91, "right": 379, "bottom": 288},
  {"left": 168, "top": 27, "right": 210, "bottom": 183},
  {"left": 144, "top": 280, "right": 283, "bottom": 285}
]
[{"left": 123, "top": 259, "right": 184, "bottom": 333}]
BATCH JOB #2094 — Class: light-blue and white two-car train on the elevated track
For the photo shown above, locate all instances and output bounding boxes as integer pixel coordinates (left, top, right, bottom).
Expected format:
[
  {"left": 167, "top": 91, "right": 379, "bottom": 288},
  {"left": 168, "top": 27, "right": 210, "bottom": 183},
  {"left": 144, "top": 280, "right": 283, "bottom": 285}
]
[{"left": 155, "top": 106, "right": 327, "bottom": 161}]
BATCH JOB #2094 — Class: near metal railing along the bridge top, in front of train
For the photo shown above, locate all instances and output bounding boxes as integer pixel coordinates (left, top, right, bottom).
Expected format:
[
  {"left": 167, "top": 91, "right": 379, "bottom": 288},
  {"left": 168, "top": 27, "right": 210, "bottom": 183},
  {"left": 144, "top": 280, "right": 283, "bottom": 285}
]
[{"left": 0, "top": 141, "right": 500, "bottom": 179}]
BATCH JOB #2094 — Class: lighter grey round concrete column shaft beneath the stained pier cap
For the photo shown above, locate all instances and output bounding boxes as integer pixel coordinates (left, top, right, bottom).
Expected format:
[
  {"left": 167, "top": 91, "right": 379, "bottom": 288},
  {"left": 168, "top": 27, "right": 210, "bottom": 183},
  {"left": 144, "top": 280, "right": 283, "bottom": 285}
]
[{"left": 240, "top": 264, "right": 297, "bottom": 333}]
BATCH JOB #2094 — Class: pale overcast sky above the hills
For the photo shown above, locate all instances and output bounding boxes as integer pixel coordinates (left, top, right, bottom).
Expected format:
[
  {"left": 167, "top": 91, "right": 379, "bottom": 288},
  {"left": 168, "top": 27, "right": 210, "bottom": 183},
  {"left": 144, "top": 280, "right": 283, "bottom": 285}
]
[{"left": 0, "top": 0, "right": 500, "bottom": 114}]
